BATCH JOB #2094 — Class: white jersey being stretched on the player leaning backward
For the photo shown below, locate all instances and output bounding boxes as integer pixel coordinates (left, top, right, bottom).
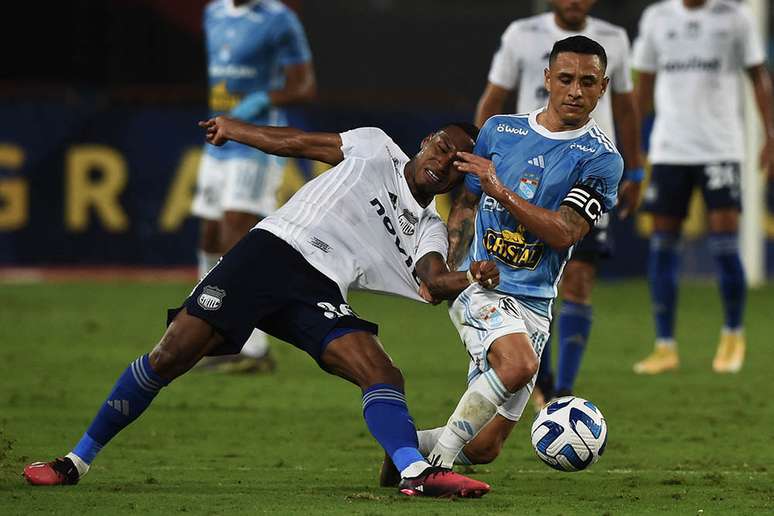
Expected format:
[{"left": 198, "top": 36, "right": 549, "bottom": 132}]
[{"left": 256, "top": 127, "right": 448, "bottom": 301}]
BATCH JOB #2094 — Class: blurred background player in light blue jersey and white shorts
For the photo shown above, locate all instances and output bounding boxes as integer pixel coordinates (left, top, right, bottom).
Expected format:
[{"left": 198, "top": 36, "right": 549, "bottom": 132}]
[{"left": 192, "top": 0, "right": 316, "bottom": 372}]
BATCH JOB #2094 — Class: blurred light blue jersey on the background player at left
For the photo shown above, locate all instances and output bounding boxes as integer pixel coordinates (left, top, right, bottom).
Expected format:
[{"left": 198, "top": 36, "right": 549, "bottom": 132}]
[{"left": 204, "top": 0, "right": 311, "bottom": 159}]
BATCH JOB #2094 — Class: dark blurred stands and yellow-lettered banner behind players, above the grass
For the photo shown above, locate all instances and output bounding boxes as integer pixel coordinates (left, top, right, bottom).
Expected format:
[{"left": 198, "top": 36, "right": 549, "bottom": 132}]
[{"left": 0, "top": 0, "right": 774, "bottom": 276}]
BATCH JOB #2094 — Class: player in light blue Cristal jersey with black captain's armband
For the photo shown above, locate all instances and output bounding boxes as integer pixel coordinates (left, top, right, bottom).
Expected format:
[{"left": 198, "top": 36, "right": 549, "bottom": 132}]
[{"left": 380, "top": 36, "right": 623, "bottom": 476}]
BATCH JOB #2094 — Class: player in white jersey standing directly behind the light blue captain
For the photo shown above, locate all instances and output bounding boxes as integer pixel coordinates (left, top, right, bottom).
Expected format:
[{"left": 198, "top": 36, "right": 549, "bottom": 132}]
[{"left": 476, "top": 0, "right": 644, "bottom": 407}]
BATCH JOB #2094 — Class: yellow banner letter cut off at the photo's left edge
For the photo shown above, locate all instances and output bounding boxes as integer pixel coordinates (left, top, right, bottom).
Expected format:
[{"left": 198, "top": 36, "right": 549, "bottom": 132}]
[{"left": 0, "top": 143, "right": 29, "bottom": 231}]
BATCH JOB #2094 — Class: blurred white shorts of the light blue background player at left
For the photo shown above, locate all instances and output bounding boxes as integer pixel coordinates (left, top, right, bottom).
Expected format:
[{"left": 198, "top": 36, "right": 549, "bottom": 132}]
[{"left": 191, "top": 153, "right": 285, "bottom": 220}]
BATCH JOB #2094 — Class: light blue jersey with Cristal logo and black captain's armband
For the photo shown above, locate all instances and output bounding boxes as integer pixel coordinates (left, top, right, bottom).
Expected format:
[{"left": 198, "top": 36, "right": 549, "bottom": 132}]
[{"left": 461, "top": 110, "right": 623, "bottom": 315}]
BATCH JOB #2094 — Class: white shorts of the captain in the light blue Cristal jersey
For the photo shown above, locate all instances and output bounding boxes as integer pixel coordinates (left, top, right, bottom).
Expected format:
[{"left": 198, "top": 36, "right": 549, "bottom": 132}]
[{"left": 449, "top": 283, "right": 550, "bottom": 421}]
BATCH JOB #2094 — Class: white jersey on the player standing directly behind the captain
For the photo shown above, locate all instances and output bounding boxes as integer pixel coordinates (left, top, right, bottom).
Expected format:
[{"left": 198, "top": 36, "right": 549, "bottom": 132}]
[{"left": 489, "top": 13, "right": 632, "bottom": 141}]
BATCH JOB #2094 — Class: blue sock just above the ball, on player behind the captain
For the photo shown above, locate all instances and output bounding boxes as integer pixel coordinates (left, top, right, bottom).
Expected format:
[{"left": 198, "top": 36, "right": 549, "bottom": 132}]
[{"left": 556, "top": 301, "right": 591, "bottom": 391}]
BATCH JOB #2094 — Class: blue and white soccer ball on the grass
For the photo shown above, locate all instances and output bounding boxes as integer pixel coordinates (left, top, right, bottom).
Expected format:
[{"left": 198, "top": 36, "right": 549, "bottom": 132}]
[{"left": 532, "top": 396, "right": 607, "bottom": 471}]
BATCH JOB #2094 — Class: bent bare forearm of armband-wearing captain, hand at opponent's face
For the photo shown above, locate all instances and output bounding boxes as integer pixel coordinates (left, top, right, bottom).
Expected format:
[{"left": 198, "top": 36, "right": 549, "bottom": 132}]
[{"left": 454, "top": 152, "right": 591, "bottom": 251}]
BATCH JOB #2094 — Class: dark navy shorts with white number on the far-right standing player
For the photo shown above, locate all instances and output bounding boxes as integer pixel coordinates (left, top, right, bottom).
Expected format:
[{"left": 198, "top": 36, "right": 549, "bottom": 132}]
[{"left": 642, "top": 161, "right": 742, "bottom": 219}]
